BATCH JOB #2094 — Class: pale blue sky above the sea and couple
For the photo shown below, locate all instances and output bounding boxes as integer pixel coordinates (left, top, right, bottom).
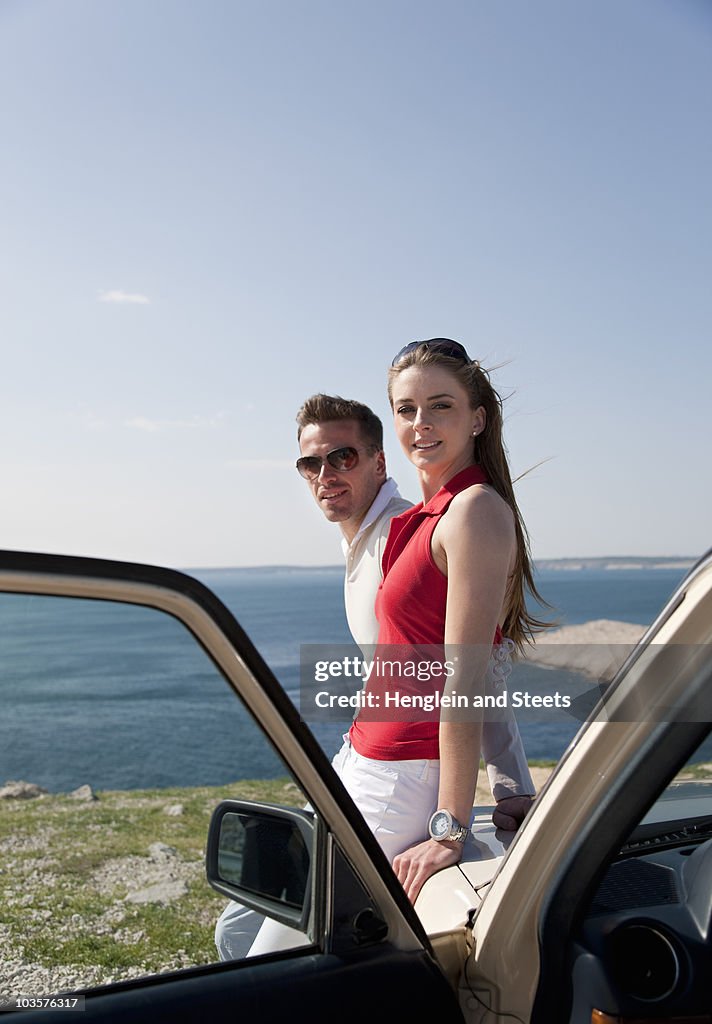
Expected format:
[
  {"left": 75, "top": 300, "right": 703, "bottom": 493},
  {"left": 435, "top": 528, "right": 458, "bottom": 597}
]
[{"left": 0, "top": 0, "right": 712, "bottom": 567}]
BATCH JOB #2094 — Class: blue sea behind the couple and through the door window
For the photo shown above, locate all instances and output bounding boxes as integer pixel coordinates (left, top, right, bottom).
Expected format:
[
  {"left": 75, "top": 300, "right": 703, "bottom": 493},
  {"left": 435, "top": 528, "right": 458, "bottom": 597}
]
[{"left": 0, "top": 563, "right": 712, "bottom": 792}]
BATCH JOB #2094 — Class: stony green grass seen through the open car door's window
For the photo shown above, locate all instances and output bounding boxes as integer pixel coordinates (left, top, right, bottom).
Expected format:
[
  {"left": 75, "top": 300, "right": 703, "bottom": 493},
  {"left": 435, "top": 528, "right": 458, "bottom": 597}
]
[{"left": 0, "top": 778, "right": 304, "bottom": 991}]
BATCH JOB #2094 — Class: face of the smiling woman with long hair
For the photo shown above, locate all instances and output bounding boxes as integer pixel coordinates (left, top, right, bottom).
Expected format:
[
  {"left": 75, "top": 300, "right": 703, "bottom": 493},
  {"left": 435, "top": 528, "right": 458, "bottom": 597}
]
[{"left": 391, "top": 367, "right": 485, "bottom": 479}]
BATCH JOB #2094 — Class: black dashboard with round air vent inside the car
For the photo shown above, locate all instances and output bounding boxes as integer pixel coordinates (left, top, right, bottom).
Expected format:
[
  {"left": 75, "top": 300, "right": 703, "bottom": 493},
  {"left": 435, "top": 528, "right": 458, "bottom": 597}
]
[{"left": 572, "top": 794, "right": 712, "bottom": 1024}]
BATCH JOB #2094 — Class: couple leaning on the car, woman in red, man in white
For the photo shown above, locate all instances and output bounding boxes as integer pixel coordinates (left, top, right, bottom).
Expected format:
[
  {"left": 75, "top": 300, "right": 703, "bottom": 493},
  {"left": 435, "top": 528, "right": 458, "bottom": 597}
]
[{"left": 215, "top": 338, "right": 541, "bottom": 959}]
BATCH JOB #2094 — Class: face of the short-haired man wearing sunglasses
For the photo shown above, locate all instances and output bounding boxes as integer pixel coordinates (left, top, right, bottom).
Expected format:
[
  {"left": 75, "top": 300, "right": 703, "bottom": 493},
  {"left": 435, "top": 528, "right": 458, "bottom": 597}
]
[{"left": 299, "top": 420, "right": 385, "bottom": 541}]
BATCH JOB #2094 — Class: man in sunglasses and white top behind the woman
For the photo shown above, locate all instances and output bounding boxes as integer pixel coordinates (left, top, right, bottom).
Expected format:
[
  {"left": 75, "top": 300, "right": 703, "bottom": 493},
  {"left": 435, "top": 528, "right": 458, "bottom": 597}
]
[{"left": 297, "top": 394, "right": 535, "bottom": 831}]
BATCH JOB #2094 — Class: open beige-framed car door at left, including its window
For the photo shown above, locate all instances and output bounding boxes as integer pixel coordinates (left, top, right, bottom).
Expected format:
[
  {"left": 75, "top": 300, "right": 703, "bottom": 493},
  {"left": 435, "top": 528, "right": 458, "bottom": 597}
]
[{"left": 0, "top": 552, "right": 462, "bottom": 1024}]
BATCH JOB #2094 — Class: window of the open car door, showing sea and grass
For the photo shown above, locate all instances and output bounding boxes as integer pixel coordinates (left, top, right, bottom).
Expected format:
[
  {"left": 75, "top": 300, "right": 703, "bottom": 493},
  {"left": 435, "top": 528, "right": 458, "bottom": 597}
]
[{"left": 0, "top": 594, "right": 311, "bottom": 995}]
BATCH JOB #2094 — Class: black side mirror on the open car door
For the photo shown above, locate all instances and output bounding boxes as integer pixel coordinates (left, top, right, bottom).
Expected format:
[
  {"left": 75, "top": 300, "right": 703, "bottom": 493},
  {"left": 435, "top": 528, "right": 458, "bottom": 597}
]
[{"left": 206, "top": 800, "right": 317, "bottom": 932}]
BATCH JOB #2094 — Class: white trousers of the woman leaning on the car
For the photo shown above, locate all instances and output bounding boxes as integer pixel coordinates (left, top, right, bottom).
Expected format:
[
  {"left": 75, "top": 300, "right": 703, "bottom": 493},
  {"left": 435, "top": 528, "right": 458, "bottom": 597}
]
[{"left": 215, "top": 736, "right": 441, "bottom": 959}]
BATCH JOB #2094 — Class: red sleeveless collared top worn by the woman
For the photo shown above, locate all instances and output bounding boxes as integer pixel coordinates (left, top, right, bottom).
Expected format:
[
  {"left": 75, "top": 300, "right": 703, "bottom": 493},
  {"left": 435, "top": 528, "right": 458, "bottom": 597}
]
[{"left": 349, "top": 466, "right": 502, "bottom": 761}]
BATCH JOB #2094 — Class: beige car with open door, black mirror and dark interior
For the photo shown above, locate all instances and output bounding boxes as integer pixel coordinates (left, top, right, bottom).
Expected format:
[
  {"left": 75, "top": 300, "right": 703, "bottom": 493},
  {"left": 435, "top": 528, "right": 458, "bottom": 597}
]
[{"left": 0, "top": 552, "right": 712, "bottom": 1024}]
